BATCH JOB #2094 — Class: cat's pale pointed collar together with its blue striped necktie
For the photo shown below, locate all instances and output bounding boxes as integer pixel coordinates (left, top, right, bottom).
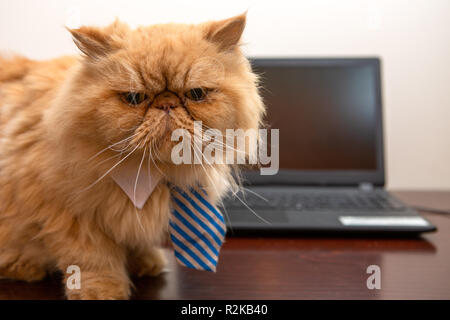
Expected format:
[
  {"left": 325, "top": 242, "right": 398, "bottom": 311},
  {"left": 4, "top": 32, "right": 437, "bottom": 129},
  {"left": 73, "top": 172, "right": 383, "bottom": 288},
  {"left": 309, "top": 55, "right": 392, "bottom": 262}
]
[{"left": 111, "top": 154, "right": 226, "bottom": 271}]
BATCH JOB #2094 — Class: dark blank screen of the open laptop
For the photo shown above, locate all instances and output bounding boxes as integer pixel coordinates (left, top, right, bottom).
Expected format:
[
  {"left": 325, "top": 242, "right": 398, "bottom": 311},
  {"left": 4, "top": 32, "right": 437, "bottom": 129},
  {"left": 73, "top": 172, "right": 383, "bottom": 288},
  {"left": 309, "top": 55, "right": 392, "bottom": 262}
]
[{"left": 253, "top": 65, "right": 377, "bottom": 171}]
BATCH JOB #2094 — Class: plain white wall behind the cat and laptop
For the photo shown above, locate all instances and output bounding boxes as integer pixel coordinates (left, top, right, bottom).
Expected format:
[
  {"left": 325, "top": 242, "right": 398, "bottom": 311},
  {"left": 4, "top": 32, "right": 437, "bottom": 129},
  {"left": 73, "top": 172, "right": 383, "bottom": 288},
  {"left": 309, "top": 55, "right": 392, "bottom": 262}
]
[{"left": 0, "top": 0, "right": 450, "bottom": 189}]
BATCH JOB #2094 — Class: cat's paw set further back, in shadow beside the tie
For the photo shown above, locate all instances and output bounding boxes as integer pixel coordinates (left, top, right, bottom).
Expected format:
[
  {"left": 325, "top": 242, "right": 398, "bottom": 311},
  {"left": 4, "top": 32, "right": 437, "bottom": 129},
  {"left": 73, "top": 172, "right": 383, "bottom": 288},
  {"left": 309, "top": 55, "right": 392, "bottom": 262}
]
[{"left": 130, "top": 248, "right": 167, "bottom": 277}]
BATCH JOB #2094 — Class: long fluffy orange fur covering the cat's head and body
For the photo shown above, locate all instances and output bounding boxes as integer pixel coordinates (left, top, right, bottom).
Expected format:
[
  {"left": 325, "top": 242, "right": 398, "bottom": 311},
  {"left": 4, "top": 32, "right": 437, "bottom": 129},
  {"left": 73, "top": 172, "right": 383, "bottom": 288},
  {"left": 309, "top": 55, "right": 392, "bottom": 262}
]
[{"left": 0, "top": 15, "right": 264, "bottom": 299}]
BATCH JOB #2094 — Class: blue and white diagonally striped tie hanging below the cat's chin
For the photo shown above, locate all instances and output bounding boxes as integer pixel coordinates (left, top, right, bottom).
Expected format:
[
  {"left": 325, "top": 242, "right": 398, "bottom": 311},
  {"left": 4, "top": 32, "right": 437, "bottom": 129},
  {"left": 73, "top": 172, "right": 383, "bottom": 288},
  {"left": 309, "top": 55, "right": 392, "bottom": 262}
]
[{"left": 169, "top": 187, "right": 226, "bottom": 272}]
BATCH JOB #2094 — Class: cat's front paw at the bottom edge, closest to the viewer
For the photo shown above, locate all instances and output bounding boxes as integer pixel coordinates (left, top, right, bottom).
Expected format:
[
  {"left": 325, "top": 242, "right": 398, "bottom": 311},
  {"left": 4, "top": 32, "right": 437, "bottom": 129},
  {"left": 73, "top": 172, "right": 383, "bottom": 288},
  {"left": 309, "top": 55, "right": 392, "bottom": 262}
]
[{"left": 66, "top": 272, "right": 130, "bottom": 300}]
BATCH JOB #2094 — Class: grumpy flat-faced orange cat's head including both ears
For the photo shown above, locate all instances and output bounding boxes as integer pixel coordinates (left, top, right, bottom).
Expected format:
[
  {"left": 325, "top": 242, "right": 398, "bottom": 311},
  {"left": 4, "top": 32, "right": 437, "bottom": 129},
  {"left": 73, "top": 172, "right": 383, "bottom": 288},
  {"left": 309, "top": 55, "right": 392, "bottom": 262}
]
[{"left": 63, "top": 15, "right": 263, "bottom": 161}]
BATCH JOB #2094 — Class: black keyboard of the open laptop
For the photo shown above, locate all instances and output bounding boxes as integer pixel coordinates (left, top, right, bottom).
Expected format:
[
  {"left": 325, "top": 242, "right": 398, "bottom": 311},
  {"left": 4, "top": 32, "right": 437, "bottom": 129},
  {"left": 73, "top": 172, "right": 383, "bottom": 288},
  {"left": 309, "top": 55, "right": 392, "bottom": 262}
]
[{"left": 224, "top": 190, "right": 405, "bottom": 211}]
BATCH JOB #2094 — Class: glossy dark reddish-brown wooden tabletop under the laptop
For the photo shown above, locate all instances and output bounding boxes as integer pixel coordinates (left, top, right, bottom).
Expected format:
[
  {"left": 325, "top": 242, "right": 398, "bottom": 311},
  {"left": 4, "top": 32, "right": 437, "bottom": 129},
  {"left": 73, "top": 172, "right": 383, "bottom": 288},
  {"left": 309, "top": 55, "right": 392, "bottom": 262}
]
[{"left": 0, "top": 191, "right": 450, "bottom": 299}]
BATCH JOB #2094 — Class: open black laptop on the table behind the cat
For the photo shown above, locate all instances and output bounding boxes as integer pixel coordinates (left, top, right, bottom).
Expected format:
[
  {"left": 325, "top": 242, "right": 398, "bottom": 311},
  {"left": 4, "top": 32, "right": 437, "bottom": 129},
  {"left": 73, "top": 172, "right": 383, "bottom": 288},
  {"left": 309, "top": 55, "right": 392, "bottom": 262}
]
[{"left": 223, "top": 58, "right": 436, "bottom": 235}]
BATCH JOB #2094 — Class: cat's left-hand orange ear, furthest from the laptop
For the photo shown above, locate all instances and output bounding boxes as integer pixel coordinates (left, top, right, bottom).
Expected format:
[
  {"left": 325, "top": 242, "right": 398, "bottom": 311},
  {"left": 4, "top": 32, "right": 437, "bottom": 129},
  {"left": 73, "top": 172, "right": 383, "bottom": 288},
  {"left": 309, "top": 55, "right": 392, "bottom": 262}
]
[{"left": 68, "top": 20, "right": 128, "bottom": 59}]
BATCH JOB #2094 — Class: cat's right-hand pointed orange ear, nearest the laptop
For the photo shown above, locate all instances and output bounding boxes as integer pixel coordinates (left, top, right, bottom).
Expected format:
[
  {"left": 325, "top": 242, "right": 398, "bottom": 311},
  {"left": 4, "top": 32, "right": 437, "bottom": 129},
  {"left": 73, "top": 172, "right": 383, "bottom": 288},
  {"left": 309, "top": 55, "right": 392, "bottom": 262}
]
[{"left": 206, "top": 12, "right": 247, "bottom": 50}]
